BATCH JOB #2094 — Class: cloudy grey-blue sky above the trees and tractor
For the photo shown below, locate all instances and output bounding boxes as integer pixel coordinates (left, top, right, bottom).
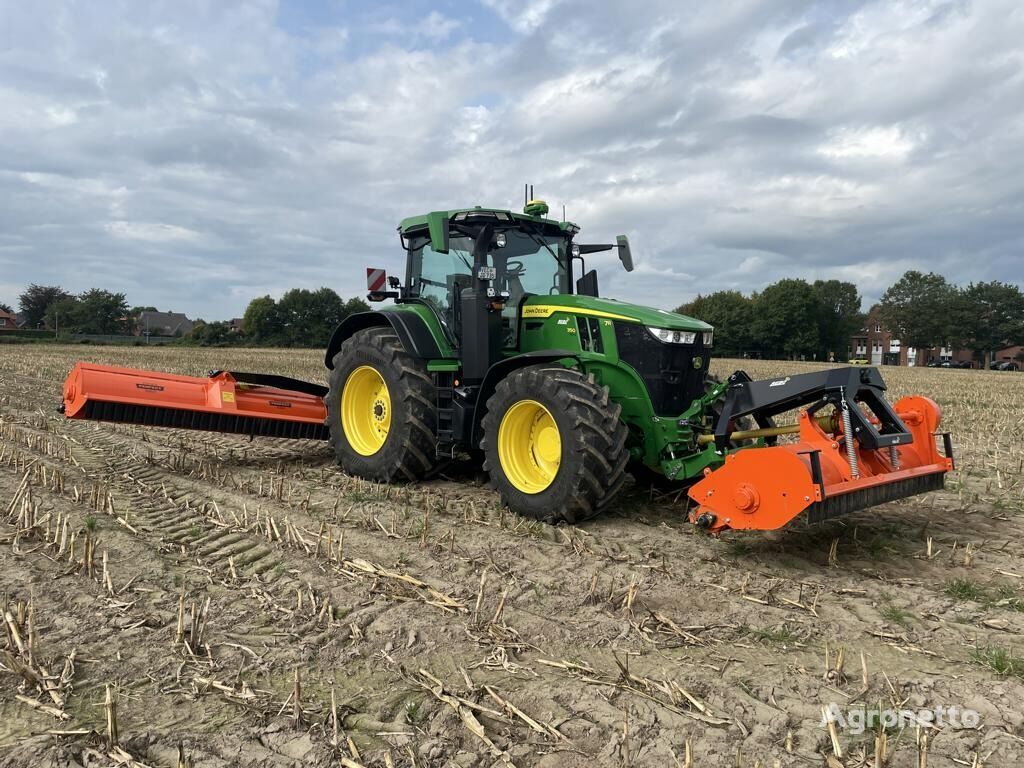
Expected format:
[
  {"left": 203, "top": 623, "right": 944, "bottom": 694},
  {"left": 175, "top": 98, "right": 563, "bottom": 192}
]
[{"left": 0, "top": 0, "right": 1024, "bottom": 319}]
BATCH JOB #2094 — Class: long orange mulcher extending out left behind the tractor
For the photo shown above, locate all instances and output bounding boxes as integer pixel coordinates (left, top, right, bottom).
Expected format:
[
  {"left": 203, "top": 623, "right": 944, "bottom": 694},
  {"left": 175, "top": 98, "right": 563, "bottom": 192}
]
[{"left": 58, "top": 362, "right": 328, "bottom": 440}]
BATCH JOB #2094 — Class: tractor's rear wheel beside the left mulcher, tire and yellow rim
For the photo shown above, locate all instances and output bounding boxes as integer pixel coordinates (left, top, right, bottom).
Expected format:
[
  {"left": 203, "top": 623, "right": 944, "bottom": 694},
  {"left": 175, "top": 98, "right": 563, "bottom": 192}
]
[{"left": 324, "top": 328, "right": 437, "bottom": 482}]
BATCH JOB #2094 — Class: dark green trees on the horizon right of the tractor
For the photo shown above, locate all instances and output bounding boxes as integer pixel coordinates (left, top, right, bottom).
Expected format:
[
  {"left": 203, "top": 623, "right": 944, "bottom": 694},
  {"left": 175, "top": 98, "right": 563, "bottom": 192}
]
[{"left": 676, "top": 270, "right": 1024, "bottom": 361}]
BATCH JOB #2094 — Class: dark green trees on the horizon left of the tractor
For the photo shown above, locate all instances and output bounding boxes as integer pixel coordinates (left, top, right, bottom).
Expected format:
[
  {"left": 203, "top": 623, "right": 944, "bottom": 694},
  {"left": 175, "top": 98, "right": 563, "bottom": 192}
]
[{"left": 0, "top": 284, "right": 370, "bottom": 347}]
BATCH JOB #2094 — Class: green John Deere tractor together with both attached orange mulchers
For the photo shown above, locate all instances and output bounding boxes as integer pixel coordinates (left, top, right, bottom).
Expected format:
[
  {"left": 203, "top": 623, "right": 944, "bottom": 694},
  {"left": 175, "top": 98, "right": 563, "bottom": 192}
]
[{"left": 60, "top": 196, "right": 953, "bottom": 532}]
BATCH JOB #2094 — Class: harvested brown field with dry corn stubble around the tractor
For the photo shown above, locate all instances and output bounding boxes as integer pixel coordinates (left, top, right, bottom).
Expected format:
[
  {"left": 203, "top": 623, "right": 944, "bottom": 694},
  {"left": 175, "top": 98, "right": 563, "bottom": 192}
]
[{"left": 0, "top": 346, "right": 1024, "bottom": 768}]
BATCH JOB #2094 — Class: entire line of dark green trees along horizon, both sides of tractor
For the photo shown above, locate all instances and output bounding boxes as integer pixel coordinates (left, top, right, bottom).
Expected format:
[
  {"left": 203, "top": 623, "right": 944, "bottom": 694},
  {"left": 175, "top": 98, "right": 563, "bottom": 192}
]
[{"left": 6, "top": 270, "right": 1024, "bottom": 361}]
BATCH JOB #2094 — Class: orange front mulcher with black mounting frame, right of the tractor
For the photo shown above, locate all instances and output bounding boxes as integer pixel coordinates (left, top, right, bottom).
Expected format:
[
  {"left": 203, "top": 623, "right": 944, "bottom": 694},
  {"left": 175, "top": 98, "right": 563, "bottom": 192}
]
[{"left": 689, "top": 368, "right": 953, "bottom": 531}]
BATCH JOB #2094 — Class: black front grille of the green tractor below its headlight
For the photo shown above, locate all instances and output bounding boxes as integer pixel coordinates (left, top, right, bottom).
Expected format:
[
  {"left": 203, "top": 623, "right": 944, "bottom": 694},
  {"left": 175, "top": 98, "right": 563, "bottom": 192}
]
[{"left": 615, "top": 323, "right": 711, "bottom": 416}]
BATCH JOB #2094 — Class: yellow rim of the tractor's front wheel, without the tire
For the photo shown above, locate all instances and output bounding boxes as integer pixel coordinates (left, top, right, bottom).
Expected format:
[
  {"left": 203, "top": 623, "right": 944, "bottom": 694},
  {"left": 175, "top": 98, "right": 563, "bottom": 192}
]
[{"left": 498, "top": 400, "right": 562, "bottom": 494}]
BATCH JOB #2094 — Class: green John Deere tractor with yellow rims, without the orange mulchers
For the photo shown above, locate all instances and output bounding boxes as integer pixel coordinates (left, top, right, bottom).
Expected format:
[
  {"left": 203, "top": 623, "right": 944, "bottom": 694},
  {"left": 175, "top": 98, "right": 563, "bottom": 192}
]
[{"left": 325, "top": 195, "right": 721, "bottom": 522}]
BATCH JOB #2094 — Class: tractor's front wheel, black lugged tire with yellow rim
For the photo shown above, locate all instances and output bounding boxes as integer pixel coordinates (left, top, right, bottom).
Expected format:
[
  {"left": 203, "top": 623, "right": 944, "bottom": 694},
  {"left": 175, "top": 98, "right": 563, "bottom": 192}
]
[{"left": 481, "top": 366, "right": 629, "bottom": 523}]
